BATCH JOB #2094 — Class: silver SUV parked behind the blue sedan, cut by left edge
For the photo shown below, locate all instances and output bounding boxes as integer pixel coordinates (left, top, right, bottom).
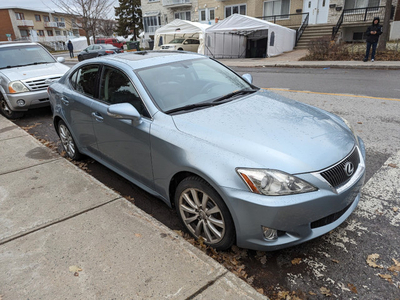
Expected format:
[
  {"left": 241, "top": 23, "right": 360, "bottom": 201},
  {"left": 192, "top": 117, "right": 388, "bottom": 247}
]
[{"left": 0, "top": 42, "right": 69, "bottom": 119}]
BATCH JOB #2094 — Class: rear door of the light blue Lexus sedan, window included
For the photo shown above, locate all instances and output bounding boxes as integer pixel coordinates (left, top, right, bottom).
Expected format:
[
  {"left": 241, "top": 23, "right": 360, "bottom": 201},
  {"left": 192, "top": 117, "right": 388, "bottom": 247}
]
[{"left": 60, "top": 64, "right": 100, "bottom": 154}]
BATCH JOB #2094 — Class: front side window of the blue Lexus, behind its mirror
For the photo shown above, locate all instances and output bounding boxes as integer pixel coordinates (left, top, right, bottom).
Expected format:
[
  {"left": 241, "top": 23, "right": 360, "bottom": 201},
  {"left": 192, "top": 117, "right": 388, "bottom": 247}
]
[{"left": 99, "top": 66, "right": 150, "bottom": 117}]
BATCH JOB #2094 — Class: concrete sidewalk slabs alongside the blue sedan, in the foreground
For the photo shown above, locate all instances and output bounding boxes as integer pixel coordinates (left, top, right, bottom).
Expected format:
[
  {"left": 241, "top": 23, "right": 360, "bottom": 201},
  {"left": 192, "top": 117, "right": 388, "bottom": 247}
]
[{"left": 0, "top": 116, "right": 267, "bottom": 300}]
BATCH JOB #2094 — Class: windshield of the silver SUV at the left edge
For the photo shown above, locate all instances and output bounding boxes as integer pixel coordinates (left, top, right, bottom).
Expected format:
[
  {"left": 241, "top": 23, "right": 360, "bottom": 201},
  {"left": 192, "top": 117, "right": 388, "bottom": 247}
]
[{"left": 0, "top": 45, "right": 55, "bottom": 69}]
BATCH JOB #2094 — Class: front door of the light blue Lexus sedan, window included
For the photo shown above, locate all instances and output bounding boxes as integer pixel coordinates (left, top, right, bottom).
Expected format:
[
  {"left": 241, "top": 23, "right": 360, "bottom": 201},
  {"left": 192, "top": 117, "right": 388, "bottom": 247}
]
[{"left": 92, "top": 66, "right": 153, "bottom": 187}]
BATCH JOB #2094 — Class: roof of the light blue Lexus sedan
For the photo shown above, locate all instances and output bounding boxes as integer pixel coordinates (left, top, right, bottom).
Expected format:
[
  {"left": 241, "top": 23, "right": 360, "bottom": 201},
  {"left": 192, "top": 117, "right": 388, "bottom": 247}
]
[{"left": 95, "top": 51, "right": 206, "bottom": 69}]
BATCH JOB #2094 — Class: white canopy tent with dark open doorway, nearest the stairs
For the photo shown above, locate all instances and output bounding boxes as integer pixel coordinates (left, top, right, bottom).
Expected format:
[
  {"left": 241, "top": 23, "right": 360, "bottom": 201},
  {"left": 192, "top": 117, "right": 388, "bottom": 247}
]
[{"left": 204, "top": 14, "right": 296, "bottom": 58}]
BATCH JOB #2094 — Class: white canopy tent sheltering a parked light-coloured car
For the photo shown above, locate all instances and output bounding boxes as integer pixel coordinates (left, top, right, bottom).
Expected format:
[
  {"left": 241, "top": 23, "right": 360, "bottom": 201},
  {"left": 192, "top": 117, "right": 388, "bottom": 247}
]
[{"left": 153, "top": 19, "right": 210, "bottom": 54}]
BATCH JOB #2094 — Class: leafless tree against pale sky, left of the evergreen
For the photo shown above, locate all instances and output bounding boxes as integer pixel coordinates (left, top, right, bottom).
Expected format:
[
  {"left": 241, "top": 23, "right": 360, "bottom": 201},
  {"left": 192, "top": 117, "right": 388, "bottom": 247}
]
[{"left": 52, "top": 0, "right": 112, "bottom": 45}]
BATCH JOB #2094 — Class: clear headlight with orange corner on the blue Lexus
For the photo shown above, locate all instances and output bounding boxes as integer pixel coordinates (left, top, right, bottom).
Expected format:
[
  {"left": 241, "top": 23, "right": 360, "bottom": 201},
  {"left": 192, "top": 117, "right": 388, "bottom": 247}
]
[{"left": 236, "top": 168, "right": 318, "bottom": 196}]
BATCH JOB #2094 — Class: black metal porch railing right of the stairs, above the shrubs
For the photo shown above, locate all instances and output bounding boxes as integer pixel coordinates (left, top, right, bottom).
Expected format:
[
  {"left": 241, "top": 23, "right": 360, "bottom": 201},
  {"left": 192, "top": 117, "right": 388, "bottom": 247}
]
[{"left": 332, "top": 6, "right": 385, "bottom": 40}]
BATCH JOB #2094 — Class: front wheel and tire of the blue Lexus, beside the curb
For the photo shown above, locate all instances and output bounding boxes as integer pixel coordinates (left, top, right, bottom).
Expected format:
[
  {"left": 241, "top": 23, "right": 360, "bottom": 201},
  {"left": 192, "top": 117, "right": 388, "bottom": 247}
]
[{"left": 175, "top": 176, "right": 235, "bottom": 250}]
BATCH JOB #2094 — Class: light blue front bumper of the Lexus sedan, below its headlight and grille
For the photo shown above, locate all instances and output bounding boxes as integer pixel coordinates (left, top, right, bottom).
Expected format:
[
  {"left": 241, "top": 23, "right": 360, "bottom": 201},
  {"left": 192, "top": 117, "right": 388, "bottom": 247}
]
[{"left": 222, "top": 146, "right": 365, "bottom": 251}]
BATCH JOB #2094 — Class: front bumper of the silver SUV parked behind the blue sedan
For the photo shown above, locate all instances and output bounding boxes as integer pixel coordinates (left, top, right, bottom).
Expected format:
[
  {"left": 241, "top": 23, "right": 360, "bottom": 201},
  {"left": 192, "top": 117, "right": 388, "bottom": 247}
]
[{"left": 5, "top": 90, "right": 50, "bottom": 111}]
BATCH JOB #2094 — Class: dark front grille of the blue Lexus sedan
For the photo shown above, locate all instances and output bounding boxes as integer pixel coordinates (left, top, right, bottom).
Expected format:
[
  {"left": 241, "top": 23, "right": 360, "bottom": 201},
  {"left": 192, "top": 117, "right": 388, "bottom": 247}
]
[{"left": 321, "top": 148, "right": 360, "bottom": 188}]
